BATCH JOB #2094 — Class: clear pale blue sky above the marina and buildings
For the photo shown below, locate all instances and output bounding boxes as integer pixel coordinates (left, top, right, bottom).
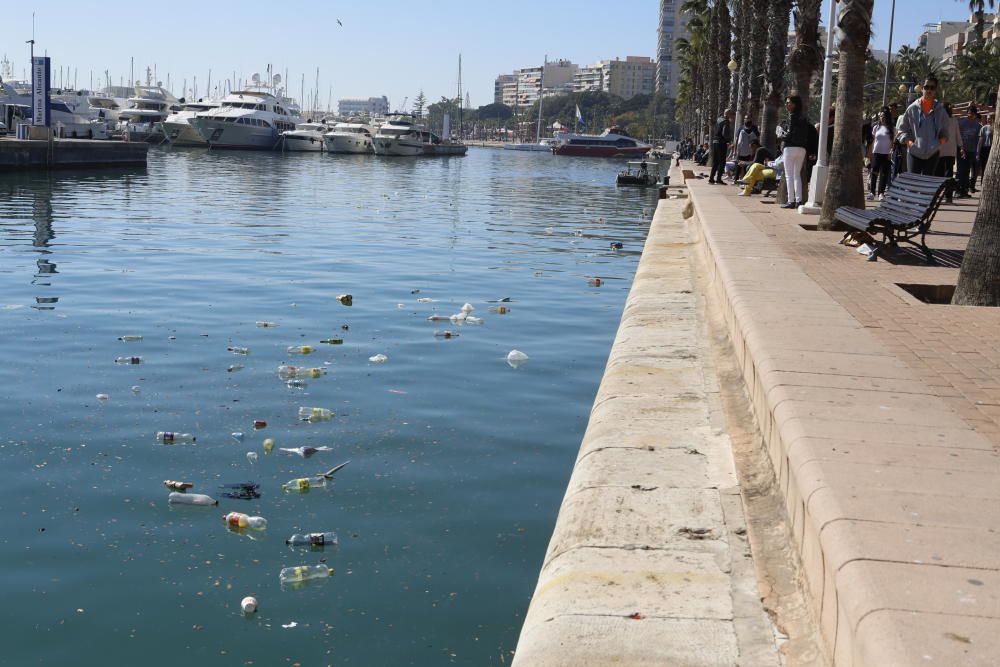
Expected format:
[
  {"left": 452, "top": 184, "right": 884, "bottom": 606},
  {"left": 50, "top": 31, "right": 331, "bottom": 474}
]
[{"left": 0, "top": 0, "right": 984, "bottom": 108}]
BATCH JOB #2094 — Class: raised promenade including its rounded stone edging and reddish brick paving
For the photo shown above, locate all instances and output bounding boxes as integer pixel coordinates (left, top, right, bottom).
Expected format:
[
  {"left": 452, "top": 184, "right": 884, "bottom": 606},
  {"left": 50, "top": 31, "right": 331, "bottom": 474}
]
[{"left": 689, "top": 174, "right": 1000, "bottom": 667}]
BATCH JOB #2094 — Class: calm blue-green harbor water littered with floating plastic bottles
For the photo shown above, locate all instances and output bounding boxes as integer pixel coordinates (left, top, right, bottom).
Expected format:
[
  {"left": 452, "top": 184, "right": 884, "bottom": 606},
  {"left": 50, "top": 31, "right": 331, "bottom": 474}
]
[{"left": 0, "top": 149, "right": 656, "bottom": 666}]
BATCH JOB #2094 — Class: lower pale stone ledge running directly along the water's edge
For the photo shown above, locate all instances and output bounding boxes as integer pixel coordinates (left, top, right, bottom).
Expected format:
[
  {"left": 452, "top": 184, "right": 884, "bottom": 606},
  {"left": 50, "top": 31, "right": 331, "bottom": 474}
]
[{"left": 513, "top": 192, "right": 780, "bottom": 667}]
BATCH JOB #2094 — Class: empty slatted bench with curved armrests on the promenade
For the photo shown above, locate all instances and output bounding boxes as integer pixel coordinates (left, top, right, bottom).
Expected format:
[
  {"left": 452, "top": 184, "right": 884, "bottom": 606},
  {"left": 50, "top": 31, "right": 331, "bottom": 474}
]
[{"left": 835, "top": 173, "right": 954, "bottom": 263}]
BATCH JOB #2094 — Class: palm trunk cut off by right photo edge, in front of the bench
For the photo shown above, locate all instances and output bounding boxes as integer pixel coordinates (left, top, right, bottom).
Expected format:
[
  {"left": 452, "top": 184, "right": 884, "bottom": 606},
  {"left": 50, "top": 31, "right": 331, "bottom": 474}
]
[{"left": 951, "top": 82, "right": 1000, "bottom": 306}]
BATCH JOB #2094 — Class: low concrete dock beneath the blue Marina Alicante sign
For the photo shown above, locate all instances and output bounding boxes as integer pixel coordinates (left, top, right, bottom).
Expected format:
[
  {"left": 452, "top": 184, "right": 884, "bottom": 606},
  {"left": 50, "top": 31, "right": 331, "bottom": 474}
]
[{"left": 0, "top": 139, "right": 149, "bottom": 171}]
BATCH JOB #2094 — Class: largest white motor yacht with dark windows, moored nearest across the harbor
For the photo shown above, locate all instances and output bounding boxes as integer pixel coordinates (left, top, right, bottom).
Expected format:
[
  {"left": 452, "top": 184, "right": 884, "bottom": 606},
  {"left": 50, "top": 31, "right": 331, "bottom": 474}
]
[{"left": 190, "top": 90, "right": 300, "bottom": 150}]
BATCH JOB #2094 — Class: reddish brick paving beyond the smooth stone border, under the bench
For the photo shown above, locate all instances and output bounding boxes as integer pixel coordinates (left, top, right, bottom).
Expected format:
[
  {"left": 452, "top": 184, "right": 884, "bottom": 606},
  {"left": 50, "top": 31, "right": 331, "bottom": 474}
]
[{"left": 717, "top": 180, "right": 1000, "bottom": 449}]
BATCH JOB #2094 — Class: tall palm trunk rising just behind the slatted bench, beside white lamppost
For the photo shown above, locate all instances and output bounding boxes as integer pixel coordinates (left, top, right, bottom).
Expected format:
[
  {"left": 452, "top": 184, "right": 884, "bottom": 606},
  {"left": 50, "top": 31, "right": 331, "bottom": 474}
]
[{"left": 819, "top": 0, "right": 874, "bottom": 230}]
